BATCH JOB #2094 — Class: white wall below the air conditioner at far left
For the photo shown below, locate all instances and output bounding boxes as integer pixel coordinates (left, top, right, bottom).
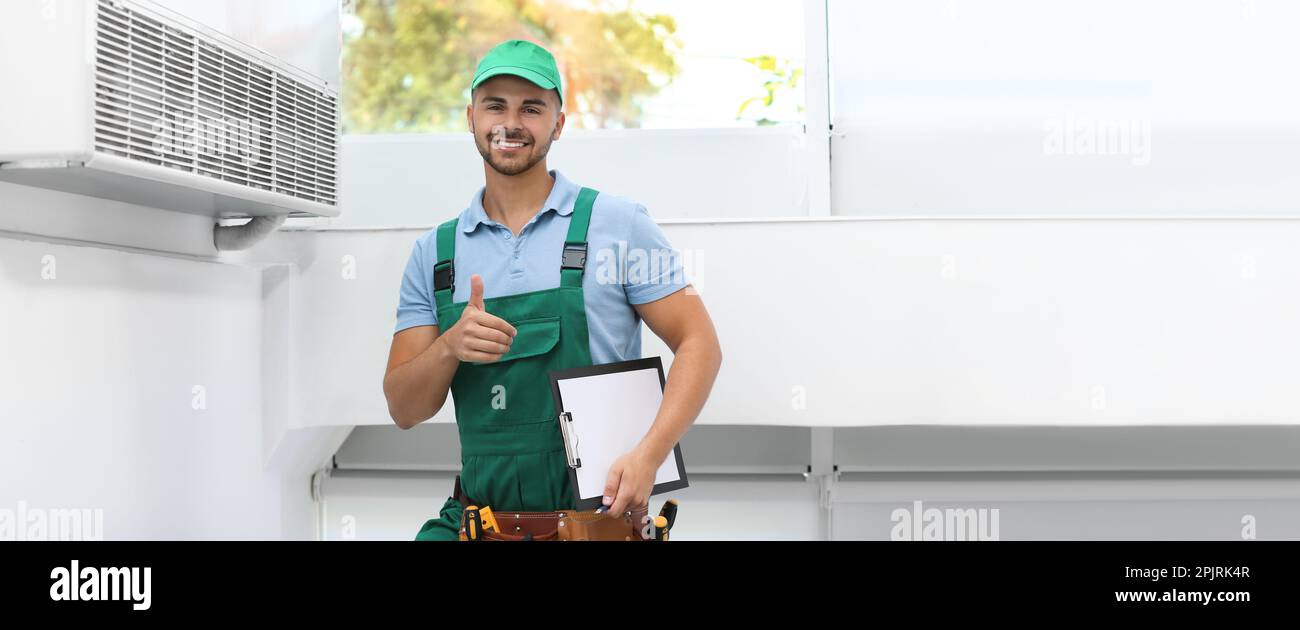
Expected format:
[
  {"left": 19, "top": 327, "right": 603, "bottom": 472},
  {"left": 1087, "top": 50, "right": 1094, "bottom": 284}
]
[{"left": 0, "top": 184, "right": 347, "bottom": 539}]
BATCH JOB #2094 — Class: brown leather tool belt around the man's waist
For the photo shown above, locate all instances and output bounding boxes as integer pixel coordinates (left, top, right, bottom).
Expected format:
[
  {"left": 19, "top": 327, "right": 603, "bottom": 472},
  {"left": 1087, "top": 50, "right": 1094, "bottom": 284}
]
[{"left": 452, "top": 475, "right": 655, "bottom": 540}]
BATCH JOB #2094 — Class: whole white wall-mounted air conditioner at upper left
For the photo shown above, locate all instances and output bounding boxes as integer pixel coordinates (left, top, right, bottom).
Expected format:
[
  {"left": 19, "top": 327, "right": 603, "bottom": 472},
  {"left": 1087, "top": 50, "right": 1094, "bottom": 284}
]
[{"left": 0, "top": 0, "right": 339, "bottom": 217}]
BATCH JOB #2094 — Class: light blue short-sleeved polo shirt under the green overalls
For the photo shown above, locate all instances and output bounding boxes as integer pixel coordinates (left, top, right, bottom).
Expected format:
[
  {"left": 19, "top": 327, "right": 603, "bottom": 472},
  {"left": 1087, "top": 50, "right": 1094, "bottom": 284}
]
[{"left": 394, "top": 170, "right": 690, "bottom": 364}]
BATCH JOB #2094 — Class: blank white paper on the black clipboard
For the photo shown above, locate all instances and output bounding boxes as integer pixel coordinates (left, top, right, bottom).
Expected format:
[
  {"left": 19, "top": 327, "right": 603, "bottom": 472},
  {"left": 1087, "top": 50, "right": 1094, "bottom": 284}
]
[{"left": 558, "top": 366, "right": 681, "bottom": 499}]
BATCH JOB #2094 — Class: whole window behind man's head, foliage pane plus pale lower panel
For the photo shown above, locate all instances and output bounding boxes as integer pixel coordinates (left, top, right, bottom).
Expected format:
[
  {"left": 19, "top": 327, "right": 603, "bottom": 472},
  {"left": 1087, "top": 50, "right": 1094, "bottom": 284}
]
[{"left": 325, "top": 0, "right": 829, "bottom": 227}]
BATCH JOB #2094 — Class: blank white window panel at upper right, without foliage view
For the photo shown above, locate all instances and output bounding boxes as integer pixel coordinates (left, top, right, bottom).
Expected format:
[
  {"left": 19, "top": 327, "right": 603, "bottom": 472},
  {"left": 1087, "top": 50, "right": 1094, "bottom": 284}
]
[{"left": 829, "top": 0, "right": 1300, "bottom": 217}]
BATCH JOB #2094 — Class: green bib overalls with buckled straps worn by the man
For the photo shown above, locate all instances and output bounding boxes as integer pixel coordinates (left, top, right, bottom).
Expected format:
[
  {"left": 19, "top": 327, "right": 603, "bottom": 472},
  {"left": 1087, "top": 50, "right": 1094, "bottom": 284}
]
[{"left": 416, "top": 188, "right": 598, "bottom": 540}]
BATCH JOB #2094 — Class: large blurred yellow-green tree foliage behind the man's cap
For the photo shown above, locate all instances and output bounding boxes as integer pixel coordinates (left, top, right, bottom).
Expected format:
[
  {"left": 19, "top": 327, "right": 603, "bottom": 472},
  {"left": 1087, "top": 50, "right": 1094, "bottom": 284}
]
[{"left": 343, "top": 0, "right": 680, "bottom": 134}]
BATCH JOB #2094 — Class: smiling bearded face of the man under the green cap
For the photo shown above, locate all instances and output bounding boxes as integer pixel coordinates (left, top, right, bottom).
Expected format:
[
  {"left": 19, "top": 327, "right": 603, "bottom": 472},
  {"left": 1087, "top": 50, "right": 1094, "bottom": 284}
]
[{"left": 465, "top": 74, "right": 564, "bottom": 175}]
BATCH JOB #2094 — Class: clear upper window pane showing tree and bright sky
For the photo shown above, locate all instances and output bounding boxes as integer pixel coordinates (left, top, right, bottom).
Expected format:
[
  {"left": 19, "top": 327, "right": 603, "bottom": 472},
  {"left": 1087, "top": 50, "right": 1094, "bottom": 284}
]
[{"left": 343, "top": 0, "right": 805, "bottom": 134}]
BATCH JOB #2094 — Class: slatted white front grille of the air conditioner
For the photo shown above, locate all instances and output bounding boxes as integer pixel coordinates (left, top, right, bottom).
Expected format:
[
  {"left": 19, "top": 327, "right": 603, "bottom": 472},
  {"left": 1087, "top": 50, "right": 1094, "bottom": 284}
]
[{"left": 95, "top": 0, "right": 338, "bottom": 205}]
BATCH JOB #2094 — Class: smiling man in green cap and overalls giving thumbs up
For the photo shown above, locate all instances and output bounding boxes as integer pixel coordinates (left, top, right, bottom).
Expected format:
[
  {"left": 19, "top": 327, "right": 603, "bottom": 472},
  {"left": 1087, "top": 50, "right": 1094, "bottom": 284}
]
[{"left": 384, "top": 40, "right": 722, "bottom": 540}]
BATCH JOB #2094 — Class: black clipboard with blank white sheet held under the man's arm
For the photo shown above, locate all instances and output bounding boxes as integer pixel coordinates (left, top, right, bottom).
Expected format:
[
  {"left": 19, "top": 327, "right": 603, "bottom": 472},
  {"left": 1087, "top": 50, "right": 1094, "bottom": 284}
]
[{"left": 550, "top": 356, "right": 689, "bottom": 509}]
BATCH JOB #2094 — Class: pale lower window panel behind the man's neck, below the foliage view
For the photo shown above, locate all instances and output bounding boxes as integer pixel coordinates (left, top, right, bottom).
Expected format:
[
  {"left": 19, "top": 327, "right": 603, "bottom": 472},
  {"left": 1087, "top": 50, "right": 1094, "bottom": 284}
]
[{"left": 322, "top": 127, "right": 807, "bottom": 227}]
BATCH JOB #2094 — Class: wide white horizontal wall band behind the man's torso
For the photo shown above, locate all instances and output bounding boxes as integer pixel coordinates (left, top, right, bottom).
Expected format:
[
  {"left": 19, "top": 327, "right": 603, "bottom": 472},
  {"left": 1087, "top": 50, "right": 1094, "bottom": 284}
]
[{"left": 250, "top": 213, "right": 1300, "bottom": 426}]
